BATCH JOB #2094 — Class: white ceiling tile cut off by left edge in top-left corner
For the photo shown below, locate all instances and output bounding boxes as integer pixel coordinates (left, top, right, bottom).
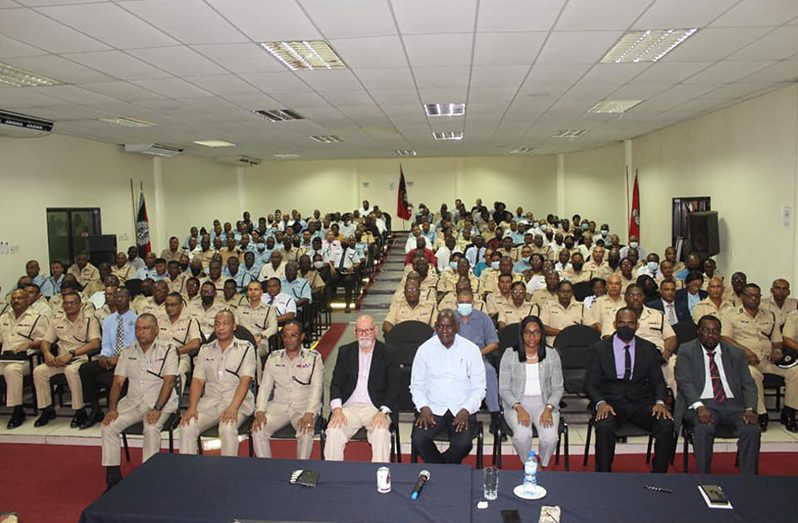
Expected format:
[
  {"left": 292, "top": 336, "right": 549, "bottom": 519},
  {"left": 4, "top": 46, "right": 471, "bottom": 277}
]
[{"left": 0, "top": 9, "right": 108, "bottom": 53}]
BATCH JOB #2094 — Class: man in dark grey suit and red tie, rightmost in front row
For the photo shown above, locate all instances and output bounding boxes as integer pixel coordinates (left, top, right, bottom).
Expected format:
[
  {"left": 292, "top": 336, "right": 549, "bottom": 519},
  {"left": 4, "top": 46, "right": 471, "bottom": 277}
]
[{"left": 676, "top": 315, "right": 761, "bottom": 474}]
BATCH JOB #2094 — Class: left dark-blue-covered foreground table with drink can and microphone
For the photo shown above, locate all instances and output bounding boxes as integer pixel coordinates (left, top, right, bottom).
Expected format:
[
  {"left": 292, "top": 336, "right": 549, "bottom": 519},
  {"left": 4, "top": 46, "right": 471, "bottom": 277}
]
[{"left": 81, "top": 454, "right": 482, "bottom": 523}]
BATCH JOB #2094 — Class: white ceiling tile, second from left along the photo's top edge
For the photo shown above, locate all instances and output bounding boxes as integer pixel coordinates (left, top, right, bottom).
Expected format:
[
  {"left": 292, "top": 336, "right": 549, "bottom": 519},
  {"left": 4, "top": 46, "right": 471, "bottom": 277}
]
[{"left": 39, "top": 2, "right": 178, "bottom": 49}]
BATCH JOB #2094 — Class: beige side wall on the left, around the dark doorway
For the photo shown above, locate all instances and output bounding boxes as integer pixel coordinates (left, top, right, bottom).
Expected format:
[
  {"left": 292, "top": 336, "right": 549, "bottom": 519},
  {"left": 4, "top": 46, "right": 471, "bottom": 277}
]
[{"left": 0, "top": 135, "right": 152, "bottom": 295}]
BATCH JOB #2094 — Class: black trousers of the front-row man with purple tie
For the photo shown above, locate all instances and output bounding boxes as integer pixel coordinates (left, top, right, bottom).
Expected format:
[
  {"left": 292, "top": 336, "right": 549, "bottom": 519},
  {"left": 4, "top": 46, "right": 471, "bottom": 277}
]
[{"left": 596, "top": 402, "right": 675, "bottom": 472}]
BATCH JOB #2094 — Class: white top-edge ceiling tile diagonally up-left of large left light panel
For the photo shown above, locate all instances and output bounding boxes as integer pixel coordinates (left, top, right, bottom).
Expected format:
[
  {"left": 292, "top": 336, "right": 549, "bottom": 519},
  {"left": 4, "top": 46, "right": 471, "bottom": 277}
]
[{"left": 122, "top": 0, "right": 247, "bottom": 44}]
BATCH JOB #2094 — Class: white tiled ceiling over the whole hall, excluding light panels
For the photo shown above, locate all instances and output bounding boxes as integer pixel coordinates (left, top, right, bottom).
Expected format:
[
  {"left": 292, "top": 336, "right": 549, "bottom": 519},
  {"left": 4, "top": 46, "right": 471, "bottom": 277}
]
[{"left": 0, "top": 0, "right": 798, "bottom": 158}]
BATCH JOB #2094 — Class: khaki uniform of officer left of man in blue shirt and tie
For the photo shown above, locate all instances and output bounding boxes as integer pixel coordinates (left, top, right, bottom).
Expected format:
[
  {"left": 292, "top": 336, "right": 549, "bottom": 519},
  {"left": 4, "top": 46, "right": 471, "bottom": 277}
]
[{"left": 33, "top": 312, "right": 102, "bottom": 410}]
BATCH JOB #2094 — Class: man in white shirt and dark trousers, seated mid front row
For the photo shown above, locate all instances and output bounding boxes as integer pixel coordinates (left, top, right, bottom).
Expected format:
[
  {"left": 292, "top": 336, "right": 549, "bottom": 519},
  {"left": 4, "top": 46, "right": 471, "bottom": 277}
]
[{"left": 410, "top": 309, "right": 485, "bottom": 463}]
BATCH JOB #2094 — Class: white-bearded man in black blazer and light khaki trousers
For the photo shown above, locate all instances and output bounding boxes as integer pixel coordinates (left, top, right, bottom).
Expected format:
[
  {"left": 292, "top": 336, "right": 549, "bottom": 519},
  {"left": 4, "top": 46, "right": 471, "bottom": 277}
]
[{"left": 324, "top": 315, "right": 399, "bottom": 463}]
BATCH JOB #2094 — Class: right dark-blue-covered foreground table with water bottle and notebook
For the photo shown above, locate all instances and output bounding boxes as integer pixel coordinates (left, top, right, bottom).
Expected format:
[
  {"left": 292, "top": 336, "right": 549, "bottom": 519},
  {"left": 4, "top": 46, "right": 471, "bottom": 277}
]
[{"left": 471, "top": 470, "right": 798, "bottom": 523}]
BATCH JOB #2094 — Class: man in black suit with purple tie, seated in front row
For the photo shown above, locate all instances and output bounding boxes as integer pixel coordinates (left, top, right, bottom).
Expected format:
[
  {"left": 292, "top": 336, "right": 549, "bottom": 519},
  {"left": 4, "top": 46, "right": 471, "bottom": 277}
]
[{"left": 585, "top": 307, "right": 674, "bottom": 472}]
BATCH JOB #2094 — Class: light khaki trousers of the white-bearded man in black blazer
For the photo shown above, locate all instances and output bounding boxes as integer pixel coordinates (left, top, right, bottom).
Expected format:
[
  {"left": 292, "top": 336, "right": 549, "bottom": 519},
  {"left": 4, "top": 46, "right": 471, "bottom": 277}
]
[{"left": 324, "top": 404, "right": 391, "bottom": 463}]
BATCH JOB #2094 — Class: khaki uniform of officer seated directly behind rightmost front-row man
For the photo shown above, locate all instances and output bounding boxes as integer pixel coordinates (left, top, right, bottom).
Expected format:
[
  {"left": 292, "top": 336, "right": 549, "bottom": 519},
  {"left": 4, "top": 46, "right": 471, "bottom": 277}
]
[{"left": 721, "top": 306, "right": 798, "bottom": 414}]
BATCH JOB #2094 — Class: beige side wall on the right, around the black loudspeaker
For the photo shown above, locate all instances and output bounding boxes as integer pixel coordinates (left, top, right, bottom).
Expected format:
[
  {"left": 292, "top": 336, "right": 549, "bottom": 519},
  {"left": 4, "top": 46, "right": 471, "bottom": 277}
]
[{"left": 633, "top": 86, "right": 798, "bottom": 286}]
